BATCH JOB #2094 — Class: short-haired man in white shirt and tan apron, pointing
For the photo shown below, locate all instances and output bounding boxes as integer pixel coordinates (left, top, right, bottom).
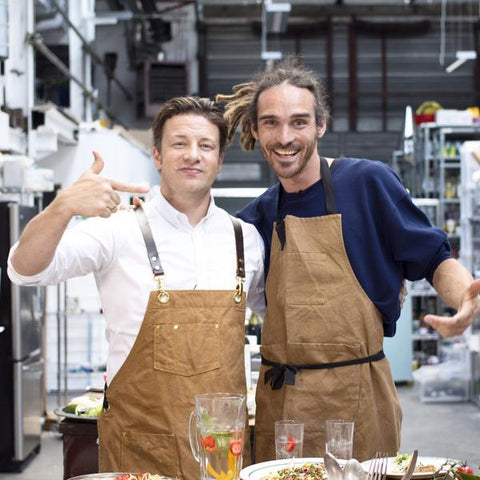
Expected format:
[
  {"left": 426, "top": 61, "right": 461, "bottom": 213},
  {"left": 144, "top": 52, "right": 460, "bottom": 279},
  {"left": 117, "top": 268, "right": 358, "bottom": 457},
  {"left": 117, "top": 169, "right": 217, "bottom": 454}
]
[{"left": 9, "top": 97, "right": 264, "bottom": 480}]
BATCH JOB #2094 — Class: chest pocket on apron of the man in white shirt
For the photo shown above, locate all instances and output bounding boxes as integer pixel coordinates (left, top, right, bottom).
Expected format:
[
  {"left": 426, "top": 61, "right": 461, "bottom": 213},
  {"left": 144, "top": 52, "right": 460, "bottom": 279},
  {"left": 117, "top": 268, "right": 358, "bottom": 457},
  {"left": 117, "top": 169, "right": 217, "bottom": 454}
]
[{"left": 154, "top": 323, "right": 220, "bottom": 377}]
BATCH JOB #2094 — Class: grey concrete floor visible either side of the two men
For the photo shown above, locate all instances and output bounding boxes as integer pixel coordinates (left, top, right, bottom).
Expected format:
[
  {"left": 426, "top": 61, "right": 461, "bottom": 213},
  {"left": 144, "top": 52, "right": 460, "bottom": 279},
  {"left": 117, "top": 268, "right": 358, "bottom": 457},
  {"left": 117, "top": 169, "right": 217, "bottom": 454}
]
[{"left": 0, "top": 386, "right": 480, "bottom": 480}]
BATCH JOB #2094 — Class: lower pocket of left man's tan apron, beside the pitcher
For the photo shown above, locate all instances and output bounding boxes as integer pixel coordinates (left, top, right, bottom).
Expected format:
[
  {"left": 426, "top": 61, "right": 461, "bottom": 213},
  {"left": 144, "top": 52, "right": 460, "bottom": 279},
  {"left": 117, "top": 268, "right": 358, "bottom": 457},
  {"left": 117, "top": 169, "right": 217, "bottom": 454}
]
[{"left": 121, "top": 432, "right": 180, "bottom": 477}]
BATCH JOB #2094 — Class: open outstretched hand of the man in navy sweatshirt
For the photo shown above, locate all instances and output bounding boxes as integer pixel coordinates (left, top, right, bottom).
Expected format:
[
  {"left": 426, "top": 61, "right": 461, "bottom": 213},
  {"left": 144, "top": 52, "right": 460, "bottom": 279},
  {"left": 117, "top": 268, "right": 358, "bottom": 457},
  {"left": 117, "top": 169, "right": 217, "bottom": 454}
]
[{"left": 425, "top": 279, "right": 480, "bottom": 337}]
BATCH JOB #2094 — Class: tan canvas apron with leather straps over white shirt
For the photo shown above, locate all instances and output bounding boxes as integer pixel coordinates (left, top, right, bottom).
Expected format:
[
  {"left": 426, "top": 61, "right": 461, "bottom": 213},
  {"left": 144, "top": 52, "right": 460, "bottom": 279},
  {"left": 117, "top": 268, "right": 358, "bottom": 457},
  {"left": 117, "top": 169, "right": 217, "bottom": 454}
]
[{"left": 98, "top": 209, "right": 250, "bottom": 480}]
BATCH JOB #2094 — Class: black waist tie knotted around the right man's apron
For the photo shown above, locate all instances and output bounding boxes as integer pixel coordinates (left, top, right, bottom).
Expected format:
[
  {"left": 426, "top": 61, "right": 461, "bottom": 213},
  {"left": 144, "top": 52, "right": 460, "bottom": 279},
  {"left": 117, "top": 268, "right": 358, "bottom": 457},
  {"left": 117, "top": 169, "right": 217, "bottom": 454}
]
[{"left": 262, "top": 349, "right": 385, "bottom": 390}]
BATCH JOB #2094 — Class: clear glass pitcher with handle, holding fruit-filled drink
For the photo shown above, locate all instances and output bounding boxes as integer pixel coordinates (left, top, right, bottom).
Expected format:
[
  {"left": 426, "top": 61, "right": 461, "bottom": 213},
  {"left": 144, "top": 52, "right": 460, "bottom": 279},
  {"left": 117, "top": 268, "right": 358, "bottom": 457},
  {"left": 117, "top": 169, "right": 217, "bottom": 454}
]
[{"left": 189, "top": 393, "right": 247, "bottom": 480}]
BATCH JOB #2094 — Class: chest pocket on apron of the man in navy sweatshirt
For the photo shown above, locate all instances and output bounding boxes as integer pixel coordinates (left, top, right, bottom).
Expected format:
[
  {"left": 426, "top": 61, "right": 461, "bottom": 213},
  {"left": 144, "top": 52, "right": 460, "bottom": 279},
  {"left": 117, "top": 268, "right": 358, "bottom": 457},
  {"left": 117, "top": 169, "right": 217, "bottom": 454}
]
[{"left": 285, "top": 253, "right": 327, "bottom": 305}]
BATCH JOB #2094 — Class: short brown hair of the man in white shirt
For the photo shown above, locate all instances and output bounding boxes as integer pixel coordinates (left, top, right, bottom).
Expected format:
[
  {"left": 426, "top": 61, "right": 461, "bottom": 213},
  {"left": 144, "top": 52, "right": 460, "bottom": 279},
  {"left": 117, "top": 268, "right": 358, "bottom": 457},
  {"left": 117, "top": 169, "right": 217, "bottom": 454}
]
[{"left": 152, "top": 97, "right": 227, "bottom": 153}]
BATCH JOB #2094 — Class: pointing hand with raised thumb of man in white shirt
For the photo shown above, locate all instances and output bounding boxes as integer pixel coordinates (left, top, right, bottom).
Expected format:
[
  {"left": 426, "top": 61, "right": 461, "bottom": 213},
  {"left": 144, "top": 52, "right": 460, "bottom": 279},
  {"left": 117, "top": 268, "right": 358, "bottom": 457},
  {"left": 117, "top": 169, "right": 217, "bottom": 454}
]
[{"left": 54, "top": 151, "right": 149, "bottom": 218}]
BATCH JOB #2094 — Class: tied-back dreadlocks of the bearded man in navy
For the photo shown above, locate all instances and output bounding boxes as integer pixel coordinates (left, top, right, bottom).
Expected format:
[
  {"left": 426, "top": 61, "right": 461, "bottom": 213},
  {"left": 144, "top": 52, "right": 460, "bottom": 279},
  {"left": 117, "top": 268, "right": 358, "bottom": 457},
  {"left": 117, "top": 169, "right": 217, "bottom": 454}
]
[{"left": 216, "top": 56, "right": 330, "bottom": 151}]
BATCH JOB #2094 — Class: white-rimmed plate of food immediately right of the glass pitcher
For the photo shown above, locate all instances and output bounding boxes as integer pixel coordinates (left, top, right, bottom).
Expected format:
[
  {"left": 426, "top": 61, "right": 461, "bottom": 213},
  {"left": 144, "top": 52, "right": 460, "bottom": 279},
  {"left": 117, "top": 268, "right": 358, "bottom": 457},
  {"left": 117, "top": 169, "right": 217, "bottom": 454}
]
[{"left": 240, "top": 457, "right": 327, "bottom": 480}]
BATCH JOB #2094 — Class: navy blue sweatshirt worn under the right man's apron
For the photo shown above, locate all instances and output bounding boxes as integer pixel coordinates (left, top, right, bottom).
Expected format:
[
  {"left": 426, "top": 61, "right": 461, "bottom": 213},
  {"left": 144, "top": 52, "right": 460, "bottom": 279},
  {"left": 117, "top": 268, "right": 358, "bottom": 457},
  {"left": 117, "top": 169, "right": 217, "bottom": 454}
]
[{"left": 238, "top": 157, "right": 451, "bottom": 337}]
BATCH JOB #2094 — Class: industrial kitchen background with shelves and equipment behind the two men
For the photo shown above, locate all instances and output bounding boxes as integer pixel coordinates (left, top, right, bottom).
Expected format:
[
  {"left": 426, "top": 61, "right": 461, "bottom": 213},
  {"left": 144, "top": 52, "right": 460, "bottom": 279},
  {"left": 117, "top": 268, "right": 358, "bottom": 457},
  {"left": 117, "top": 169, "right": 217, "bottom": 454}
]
[{"left": 0, "top": 0, "right": 480, "bottom": 471}]
